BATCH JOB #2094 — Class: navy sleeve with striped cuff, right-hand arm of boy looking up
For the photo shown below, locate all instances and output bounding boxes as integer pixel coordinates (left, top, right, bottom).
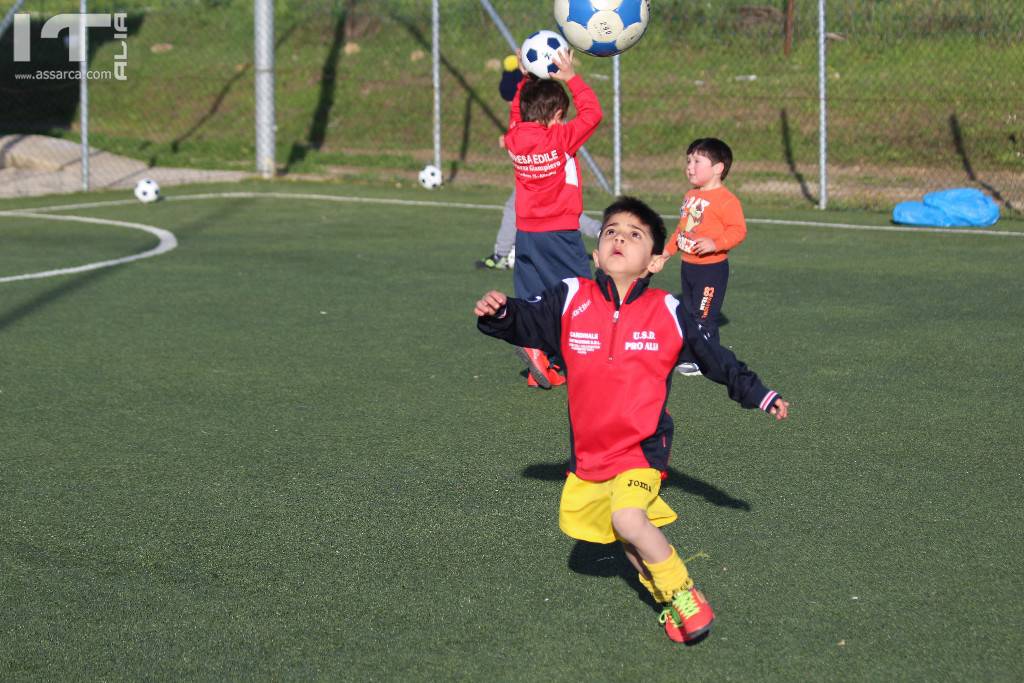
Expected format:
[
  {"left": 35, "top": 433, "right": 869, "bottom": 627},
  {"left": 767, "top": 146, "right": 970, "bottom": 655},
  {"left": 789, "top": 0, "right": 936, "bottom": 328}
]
[{"left": 676, "top": 305, "right": 779, "bottom": 412}]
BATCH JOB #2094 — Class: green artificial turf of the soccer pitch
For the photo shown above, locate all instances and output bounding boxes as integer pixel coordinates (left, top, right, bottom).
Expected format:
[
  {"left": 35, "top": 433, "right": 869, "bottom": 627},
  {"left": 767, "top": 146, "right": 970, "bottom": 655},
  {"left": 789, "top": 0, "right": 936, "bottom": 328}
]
[{"left": 0, "top": 183, "right": 1024, "bottom": 681}]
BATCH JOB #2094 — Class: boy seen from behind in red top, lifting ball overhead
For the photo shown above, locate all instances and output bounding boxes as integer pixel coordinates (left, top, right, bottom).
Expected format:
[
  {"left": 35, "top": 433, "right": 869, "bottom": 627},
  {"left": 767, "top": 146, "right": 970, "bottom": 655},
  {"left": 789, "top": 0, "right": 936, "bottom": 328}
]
[{"left": 504, "top": 51, "right": 601, "bottom": 389}]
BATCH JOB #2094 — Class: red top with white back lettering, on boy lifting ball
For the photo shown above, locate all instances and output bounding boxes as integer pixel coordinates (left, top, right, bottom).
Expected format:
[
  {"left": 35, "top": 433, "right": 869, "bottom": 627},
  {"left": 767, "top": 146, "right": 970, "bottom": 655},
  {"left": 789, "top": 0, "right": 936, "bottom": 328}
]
[{"left": 505, "top": 76, "right": 601, "bottom": 232}]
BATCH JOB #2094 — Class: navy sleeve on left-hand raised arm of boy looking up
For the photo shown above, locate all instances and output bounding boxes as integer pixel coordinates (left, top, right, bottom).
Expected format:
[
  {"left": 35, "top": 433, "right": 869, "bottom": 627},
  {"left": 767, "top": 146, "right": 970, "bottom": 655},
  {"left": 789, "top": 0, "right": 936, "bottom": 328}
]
[{"left": 476, "top": 283, "right": 568, "bottom": 355}]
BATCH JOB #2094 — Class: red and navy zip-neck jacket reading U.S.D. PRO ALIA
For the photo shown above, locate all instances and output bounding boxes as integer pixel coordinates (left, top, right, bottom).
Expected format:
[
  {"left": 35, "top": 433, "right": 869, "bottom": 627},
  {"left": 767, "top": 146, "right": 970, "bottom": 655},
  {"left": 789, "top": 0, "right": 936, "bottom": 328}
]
[{"left": 477, "top": 270, "right": 778, "bottom": 481}]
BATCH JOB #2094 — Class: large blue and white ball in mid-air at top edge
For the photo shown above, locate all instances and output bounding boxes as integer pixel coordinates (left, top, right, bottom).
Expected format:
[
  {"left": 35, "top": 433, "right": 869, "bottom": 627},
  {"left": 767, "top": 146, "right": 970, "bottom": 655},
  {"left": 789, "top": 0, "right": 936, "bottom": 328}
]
[{"left": 555, "top": 0, "right": 650, "bottom": 57}]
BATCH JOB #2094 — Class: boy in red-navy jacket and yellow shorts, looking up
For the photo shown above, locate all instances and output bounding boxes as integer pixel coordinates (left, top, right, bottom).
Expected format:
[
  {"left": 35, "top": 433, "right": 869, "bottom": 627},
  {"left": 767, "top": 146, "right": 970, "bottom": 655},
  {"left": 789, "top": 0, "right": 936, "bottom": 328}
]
[{"left": 474, "top": 197, "right": 790, "bottom": 642}]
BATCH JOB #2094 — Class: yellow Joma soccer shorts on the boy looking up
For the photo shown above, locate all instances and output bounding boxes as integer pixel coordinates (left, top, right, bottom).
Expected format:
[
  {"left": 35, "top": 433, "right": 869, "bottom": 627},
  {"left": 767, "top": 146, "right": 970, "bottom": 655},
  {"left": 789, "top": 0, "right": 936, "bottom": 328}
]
[{"left": 558, "top": 467, "right": 678, "bottom": 543}]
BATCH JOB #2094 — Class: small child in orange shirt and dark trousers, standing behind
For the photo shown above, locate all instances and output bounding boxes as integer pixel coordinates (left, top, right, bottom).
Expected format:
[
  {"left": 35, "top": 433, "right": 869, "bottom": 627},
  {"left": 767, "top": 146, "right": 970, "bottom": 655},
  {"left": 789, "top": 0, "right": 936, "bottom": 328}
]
[{"left": 662, "top": 137, "right": 746, "bottom": 375}]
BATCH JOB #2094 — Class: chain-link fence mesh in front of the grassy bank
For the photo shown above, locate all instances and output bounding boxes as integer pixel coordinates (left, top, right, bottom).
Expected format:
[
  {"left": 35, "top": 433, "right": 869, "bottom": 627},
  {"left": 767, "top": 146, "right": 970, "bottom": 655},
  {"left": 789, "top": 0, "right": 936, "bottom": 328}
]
[{"left": 0, "top": 0, "right": 1024, "bottom": 212}]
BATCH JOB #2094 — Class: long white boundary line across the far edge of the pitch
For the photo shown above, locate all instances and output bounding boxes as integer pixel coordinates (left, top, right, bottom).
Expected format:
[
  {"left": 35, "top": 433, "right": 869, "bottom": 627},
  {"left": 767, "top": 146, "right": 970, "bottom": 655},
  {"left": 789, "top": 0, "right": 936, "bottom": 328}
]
[{"left": 18, "top": 193, "right": 1024, "bottom": 238}]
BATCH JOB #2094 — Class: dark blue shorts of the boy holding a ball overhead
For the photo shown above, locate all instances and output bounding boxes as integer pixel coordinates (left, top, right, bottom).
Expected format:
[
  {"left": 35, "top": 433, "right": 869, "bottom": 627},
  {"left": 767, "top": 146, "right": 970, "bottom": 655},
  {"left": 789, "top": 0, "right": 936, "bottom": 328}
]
[{"left": 512, "top": 230, "right": 591, "bottom": 299}]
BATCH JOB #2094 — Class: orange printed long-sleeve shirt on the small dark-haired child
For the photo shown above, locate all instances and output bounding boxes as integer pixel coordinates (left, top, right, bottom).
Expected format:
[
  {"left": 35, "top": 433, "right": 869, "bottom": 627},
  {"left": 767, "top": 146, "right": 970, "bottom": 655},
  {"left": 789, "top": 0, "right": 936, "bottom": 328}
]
[{"left": 665, "top": 186, "right": 746, "bottom": 264}]
